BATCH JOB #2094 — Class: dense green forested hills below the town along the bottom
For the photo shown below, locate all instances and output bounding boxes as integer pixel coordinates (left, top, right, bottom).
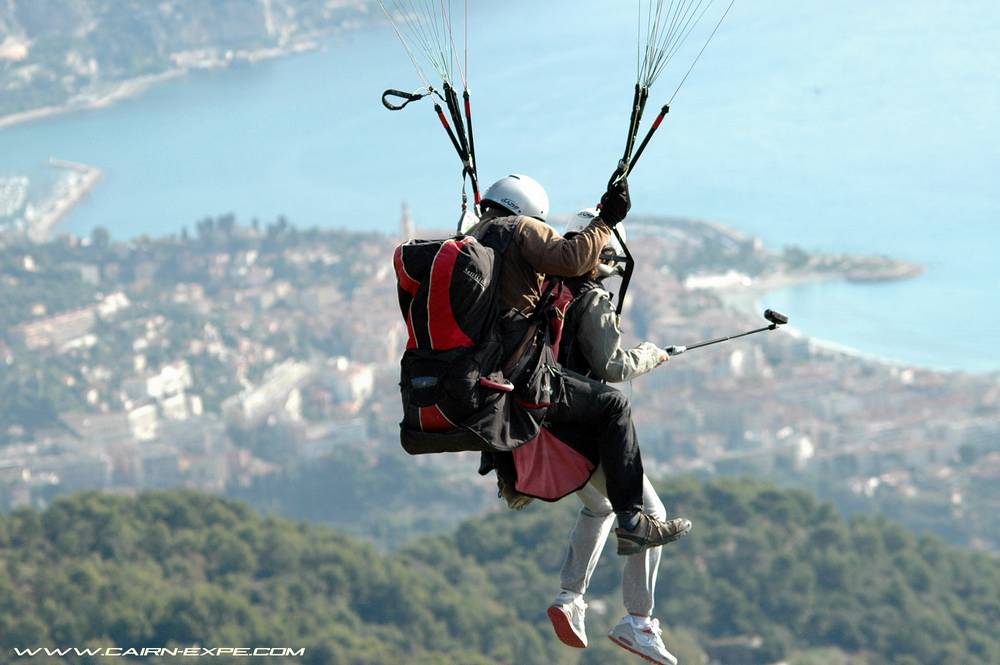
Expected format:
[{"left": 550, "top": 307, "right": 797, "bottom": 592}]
[{"left": 0, "top": 479, "right": 1000, "bottom": 665}]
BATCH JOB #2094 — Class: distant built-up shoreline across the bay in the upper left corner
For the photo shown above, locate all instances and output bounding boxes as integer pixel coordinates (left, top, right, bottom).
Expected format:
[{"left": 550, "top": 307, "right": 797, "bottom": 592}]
[{"left": 0, "top": 0, "right": 371, "bottom": 124}]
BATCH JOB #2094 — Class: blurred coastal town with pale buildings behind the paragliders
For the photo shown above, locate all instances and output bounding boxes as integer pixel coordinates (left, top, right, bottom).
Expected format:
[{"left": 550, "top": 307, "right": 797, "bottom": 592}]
[{"left": 0, "top": 209, "right": 1000, "bottom": 549}]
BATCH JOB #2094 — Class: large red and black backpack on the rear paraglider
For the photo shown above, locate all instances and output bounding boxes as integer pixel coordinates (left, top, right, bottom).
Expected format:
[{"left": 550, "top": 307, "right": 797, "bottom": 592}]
[{"left": 393, "top": 219, "right": 516, "bottom": 453}]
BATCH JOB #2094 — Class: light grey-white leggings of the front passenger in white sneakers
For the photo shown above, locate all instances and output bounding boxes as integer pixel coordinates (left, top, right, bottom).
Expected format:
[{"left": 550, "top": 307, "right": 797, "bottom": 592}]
[{"left": 560, "top": 467, "right": 667, "bottom": 616}]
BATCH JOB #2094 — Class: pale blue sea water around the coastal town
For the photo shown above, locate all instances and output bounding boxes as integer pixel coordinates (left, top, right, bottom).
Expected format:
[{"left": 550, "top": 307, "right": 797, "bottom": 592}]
[{"left": 0, "top": 0, "right": 1000, "bottom": 372}]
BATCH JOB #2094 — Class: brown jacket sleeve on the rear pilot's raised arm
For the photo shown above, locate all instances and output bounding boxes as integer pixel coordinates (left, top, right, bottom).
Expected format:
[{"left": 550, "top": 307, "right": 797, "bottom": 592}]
[{"left": 514, "top": 217, "right": 611, "bottom": 277}]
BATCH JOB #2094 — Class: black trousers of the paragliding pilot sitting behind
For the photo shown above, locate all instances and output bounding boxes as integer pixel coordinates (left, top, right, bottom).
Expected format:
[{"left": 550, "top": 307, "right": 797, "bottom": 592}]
[{"left": 545, "top": 368, "right": 643, "bottom": 513}]
